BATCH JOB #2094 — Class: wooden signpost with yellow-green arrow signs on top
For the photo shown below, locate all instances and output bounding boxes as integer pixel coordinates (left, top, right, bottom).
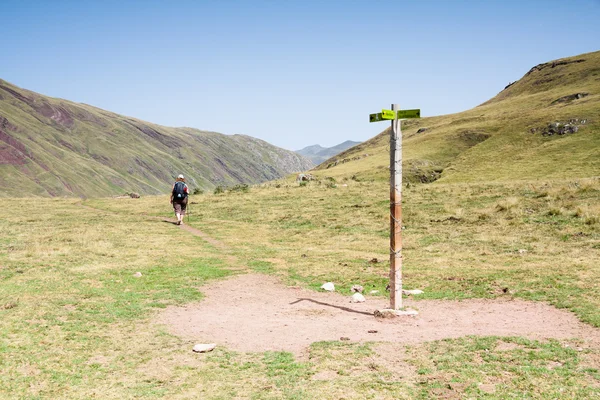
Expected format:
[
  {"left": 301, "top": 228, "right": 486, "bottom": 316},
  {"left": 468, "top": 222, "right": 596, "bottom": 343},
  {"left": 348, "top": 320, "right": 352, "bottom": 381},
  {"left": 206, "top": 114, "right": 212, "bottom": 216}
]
[{"left": 369, "top": 104, "right": 421, "bottom": 310}]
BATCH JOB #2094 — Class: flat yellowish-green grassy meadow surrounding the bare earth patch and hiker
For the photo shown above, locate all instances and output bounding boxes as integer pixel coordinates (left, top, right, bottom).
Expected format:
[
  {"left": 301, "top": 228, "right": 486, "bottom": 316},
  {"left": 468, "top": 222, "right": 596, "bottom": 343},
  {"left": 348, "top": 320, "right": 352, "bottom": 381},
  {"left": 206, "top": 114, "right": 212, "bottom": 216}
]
[{"left": 0, "top": 178, "right": 600, "bottom": 399}]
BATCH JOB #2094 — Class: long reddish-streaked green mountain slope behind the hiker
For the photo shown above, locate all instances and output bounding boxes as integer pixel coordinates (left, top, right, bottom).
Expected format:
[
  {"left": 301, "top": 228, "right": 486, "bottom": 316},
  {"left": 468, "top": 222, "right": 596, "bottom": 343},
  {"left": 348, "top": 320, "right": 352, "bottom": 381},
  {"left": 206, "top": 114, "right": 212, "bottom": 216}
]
[{"left": 0, "top": 80, "right": 313, "bottom": 197}]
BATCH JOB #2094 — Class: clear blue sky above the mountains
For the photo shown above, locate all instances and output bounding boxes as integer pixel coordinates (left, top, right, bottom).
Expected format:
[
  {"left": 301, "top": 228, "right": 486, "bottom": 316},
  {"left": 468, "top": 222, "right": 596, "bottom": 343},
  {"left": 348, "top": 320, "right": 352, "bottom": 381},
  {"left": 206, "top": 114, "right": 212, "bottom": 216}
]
[{"left": 0, "top": 0, "right": 600, "bottom": 150}]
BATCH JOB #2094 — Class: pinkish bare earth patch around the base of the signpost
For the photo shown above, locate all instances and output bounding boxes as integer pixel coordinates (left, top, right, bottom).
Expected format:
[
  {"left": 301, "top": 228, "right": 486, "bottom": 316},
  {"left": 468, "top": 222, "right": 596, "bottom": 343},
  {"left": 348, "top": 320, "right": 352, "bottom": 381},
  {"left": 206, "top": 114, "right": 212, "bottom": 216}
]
[{"left": 158, "top": 274, "right": 600, "bottom": 355}]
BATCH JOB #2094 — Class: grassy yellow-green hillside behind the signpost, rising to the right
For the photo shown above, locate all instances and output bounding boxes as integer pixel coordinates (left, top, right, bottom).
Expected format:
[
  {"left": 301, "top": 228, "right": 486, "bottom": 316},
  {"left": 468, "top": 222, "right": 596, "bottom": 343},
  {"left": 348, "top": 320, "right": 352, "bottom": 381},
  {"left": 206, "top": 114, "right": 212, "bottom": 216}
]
[{"left": 314, "top": 48, "right": 600, "bottom": 182}]
